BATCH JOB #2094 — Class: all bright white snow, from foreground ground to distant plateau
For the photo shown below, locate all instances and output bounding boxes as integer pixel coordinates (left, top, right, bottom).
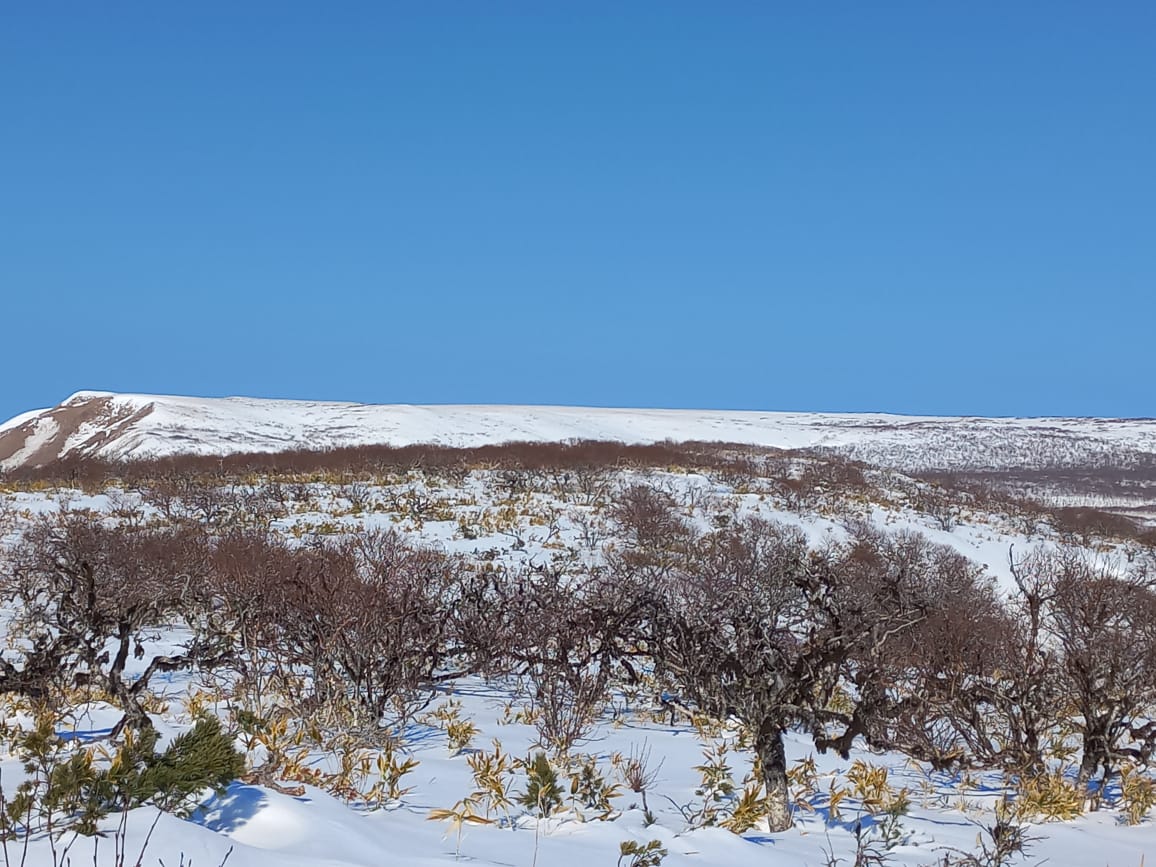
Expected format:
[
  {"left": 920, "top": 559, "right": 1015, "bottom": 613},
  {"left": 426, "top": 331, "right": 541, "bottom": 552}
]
[{"left": 0, "top": 425, "right": 1156, "bottom": 867}]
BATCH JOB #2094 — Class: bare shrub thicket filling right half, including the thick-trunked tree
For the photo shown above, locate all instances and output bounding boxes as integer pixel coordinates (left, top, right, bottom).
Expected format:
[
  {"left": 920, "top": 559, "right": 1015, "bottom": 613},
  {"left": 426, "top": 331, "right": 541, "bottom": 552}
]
[{"left": 609, "top": 490, "right": 1156, "bottom": 825}]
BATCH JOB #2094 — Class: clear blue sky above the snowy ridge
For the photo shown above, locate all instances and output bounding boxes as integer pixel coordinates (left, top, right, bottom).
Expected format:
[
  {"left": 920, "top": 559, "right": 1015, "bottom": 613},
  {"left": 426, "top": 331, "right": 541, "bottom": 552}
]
[{"left": 0, "top": 0, "right": 1156, "bottom": 417}]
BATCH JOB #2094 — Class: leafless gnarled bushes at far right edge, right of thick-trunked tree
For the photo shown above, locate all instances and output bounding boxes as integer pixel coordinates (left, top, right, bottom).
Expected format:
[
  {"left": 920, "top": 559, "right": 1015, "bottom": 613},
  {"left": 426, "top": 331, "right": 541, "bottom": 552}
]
[{"left": 881, "top": 549, "right": 1156, "bottom": 790}]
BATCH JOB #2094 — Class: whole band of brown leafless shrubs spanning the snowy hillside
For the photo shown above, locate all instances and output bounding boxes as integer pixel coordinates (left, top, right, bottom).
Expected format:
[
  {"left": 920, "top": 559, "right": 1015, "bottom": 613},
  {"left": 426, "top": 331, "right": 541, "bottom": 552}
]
[{"left": 0, "top": 464, "right": 1156, "bottom": 828}]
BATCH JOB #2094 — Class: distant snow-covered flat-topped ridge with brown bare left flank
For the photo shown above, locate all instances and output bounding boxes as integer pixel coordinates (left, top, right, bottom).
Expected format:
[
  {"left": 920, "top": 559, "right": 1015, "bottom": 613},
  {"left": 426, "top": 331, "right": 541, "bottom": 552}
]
[{"left": 0, "top": 392, "right": 1156, "bottom": 470}]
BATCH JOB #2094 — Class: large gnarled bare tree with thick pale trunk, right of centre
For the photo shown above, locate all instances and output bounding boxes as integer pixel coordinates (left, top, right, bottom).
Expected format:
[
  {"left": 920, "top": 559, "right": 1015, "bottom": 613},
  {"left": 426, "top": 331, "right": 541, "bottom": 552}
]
[{"left": 623, "top": 519, "right": 1012, "bottom": 829}]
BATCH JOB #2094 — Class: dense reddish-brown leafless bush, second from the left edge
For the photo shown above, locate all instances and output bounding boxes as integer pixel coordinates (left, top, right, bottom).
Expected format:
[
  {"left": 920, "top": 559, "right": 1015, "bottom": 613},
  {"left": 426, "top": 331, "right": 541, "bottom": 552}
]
[{"left": 206, "top": 532, "right": 492, "bottom": 725}]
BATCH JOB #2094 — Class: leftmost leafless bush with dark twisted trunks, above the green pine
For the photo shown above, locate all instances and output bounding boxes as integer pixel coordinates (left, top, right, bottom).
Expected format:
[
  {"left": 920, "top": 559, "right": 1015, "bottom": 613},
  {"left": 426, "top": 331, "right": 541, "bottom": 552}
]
[{"left": 0, "top": 512, "right": 222, "bottom": 731}]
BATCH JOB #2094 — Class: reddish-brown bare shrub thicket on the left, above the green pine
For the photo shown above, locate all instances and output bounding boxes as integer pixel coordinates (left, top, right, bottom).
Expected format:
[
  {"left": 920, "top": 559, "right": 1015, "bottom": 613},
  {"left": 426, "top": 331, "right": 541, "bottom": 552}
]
[{"left": 0, "top": 512, "right": 506, "bottom": 728}]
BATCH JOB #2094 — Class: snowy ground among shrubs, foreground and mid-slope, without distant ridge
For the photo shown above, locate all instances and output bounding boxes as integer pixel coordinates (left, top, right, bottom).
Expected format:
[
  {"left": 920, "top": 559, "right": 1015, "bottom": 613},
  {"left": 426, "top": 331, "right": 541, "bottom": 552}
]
[{"left": 0, "top": 469, "right": 1156, "bottom": 867}]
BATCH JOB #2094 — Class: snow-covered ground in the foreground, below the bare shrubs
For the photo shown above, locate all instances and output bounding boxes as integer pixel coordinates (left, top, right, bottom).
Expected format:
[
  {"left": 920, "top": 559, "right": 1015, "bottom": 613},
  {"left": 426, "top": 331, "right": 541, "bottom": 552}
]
[{"left": 11, "top": 682, "right": 1156, "bottom": 867}]
